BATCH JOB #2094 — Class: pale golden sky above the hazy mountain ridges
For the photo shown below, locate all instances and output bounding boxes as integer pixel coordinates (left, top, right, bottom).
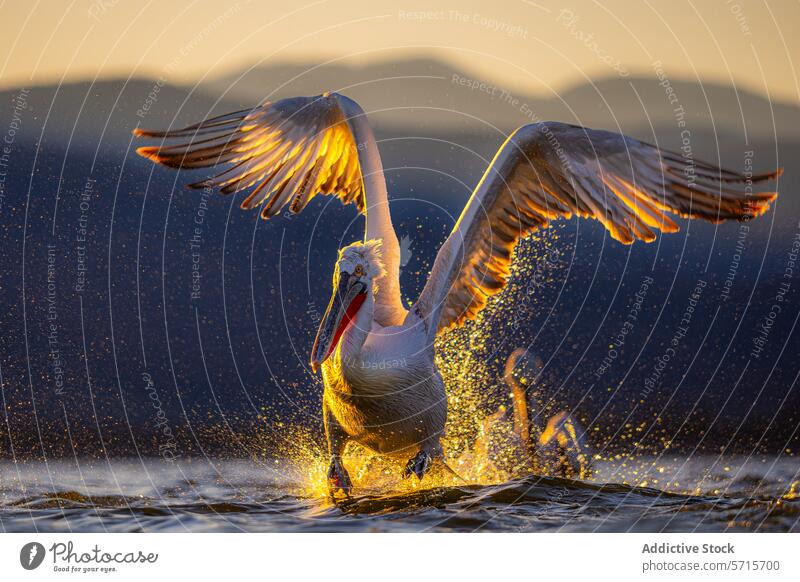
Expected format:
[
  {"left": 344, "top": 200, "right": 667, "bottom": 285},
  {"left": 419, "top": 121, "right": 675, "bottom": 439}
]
[{"left": 0, "top": 0, "right": 800, "bottom": 103}]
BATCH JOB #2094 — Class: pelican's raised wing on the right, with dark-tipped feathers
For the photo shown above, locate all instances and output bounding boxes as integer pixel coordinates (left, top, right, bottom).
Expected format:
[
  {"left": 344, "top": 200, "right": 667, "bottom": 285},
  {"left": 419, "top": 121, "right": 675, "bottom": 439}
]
[{"left": 412, "top": 122, "right": 781, "bottom": 337}]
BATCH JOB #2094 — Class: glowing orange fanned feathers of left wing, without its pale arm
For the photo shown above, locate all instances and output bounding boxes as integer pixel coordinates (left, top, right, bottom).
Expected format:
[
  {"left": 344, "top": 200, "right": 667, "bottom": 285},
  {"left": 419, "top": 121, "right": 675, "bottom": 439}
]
[{"left": 133, "top": 93, "right": 366, "bottom": 219}]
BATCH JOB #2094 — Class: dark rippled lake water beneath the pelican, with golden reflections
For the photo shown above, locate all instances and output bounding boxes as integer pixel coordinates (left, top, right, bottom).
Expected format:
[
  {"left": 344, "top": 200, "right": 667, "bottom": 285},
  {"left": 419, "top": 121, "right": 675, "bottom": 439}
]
[{"left": 0, "top": 456, "right": 800, "bottom": 532}]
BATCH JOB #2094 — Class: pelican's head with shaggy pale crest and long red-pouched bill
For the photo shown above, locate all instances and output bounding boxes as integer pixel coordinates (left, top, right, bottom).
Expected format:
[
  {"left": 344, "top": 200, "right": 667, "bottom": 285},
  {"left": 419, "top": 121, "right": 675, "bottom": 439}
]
[{"left": 311, "top": 240, "right": 385, "bottom": 371}]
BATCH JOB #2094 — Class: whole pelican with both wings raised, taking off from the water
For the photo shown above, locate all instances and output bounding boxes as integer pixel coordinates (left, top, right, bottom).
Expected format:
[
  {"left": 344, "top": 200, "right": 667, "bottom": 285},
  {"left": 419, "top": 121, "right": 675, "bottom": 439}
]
[{"left": 133, "top": 92, "right": 780, "bottom": 496}]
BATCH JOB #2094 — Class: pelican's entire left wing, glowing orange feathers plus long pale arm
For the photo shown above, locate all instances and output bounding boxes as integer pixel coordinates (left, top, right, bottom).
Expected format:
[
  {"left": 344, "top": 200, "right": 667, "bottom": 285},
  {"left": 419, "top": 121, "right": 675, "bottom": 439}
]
[{"left": 133, "top": 93, "right": 406, "bottom": 325}]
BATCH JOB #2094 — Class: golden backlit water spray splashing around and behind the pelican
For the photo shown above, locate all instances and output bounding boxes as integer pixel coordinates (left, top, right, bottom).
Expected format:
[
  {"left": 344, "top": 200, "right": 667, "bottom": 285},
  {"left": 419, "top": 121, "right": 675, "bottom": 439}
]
[{"left": 268, "top": 230, "right": 592, "bottom": 497}]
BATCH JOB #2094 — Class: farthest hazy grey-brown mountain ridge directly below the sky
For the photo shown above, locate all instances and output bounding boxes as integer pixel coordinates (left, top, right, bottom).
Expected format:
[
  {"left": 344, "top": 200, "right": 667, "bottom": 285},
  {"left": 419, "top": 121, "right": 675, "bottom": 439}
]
[{"left": 197, "top": 59, "right": 800, "bottom": 140}]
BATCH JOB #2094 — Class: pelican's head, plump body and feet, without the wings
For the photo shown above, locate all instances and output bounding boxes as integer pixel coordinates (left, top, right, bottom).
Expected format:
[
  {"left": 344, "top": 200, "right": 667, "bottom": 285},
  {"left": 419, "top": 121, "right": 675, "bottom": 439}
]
[{"left": 311, "top": 249, "right": 447, "bottom": 490}]
